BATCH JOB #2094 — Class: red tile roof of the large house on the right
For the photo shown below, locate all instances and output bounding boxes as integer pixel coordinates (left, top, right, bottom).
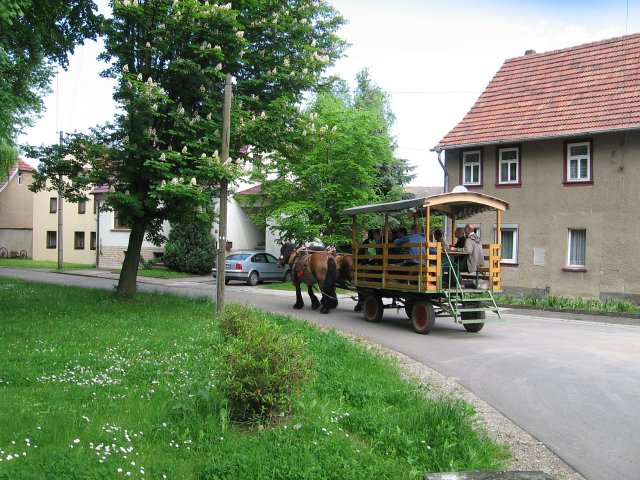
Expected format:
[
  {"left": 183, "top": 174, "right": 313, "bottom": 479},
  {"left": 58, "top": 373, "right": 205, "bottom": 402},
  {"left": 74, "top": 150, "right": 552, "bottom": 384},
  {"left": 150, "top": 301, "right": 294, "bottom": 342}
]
[{"left": 438, "top": 34, "right": 640, "bottom": 148}]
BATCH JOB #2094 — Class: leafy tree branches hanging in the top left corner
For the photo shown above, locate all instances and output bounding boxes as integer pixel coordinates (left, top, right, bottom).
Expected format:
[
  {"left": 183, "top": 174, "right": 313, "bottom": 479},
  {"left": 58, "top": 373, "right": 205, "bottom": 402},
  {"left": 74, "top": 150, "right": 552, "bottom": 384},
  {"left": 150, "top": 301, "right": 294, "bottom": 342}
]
[{"left": 0, "top": 0, "right": 102, "bottom": 172}]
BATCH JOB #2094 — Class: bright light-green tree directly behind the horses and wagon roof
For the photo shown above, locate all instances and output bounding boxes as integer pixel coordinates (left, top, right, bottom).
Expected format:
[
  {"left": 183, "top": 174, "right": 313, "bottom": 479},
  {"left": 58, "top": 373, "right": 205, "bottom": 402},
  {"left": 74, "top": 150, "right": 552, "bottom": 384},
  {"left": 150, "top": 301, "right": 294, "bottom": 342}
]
[{"left": 248, "top": 70, "right": 413, "bottom": 248}]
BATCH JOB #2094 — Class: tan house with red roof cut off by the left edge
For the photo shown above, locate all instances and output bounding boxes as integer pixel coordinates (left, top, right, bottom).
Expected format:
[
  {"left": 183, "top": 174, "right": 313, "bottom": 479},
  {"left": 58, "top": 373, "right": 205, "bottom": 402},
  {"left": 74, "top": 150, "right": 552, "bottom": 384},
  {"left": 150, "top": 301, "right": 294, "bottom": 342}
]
[{"left": 0, "top": 159, "right": 35, "bottom": 257}]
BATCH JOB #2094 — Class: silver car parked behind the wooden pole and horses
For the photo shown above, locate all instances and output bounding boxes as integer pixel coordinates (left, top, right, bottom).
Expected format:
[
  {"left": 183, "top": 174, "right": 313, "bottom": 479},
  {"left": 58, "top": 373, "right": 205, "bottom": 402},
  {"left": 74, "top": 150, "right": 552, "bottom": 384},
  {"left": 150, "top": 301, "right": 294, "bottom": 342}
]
[{"left": 211, "top": 250, "right": 291, "bottom": 286}]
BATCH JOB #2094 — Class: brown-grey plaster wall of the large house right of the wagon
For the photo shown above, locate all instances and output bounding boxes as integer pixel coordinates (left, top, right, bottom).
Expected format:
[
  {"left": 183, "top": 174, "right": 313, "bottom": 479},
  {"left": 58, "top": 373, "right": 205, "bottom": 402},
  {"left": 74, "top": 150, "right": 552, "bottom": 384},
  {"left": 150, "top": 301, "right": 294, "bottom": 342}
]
[{"left": 446, "top": 132, "right": 640, "bottom": 301}]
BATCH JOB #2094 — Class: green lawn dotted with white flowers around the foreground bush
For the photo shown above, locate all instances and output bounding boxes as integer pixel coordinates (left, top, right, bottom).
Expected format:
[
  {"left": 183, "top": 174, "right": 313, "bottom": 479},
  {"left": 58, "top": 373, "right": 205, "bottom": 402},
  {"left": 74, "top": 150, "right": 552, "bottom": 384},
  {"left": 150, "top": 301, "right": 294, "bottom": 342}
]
[{"left": 0, "top": 279, "right": 507, "bottom": 480}]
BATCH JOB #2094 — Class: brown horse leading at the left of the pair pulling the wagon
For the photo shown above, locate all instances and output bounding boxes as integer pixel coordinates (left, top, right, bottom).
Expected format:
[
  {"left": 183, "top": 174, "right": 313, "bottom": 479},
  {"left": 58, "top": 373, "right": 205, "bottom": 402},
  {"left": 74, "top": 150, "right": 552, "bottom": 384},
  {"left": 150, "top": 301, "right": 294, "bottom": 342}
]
[{"left": 278, "top": 242, "right": 338, "bottom": 313}]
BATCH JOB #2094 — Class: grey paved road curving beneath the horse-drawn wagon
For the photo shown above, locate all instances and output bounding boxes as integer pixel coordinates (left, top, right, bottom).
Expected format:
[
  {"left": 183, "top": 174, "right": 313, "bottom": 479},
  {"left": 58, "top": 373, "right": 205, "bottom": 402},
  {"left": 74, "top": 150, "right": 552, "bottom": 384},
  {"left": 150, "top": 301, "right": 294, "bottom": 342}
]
[{"left": 0, "top": 268, "right": 640, "bottom": 480}]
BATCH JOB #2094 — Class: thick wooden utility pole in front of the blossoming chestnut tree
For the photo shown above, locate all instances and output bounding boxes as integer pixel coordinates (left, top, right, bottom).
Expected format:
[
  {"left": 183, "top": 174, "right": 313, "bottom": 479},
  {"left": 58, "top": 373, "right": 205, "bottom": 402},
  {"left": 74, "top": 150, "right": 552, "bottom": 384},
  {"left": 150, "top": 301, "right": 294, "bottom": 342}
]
[{"left": 216, "top": 73, "right": 233, "bottom": 313}]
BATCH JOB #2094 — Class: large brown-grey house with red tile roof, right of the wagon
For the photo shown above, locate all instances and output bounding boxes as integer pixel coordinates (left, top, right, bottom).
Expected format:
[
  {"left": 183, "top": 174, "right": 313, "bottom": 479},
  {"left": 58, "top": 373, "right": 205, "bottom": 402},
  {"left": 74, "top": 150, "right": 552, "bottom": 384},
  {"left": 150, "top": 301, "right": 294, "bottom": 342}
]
[{"left": 434, "top": 34, "right": 640, "bottom": 301}]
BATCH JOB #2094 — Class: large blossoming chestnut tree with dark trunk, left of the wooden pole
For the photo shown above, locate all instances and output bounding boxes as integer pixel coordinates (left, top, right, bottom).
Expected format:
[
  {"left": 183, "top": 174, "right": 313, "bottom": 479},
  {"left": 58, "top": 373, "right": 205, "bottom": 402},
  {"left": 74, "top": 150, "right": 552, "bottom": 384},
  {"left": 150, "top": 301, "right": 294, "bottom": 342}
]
[{"left": 32, "top": 0, "right": 344, "bottom": 295}]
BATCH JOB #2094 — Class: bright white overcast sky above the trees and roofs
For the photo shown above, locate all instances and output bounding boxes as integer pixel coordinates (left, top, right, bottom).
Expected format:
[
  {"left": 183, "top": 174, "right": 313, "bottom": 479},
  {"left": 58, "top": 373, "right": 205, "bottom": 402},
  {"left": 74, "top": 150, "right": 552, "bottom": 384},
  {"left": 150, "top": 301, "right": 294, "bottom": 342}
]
[{"left": 21, "top": 0, "right": 640, "bottom": 186}]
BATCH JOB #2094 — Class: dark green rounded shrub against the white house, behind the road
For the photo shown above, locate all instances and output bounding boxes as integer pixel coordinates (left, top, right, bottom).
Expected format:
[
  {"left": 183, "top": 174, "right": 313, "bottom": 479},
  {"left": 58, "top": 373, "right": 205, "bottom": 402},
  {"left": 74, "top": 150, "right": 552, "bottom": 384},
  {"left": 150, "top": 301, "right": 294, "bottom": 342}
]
[{"left": 162, "top": 215, "right": 217, "bottom": 275}]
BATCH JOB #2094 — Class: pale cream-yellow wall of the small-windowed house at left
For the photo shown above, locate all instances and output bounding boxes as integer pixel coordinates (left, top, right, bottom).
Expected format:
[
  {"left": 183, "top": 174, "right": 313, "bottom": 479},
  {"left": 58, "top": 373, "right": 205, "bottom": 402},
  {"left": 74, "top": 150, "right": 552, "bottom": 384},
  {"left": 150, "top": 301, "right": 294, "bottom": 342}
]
[{"left": 33, "top": 191, "right": 97, "bottom": 265}]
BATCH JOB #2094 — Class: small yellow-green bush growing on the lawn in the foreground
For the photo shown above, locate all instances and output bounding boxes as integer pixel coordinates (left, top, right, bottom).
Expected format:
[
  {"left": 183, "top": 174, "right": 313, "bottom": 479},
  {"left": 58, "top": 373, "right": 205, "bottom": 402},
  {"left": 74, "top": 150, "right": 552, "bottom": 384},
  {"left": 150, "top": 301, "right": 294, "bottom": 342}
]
[{"left": 216, "top": 305, "right": 313, "bottom": 423}]
